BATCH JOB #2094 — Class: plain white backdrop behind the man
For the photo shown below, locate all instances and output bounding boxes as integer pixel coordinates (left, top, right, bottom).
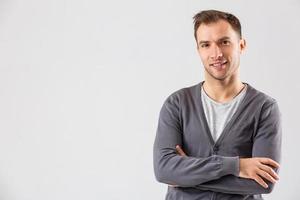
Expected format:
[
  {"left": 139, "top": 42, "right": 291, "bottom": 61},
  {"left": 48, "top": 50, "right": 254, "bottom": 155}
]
[{"left": 0, "top": 0, "right": 300, "bottom": 200}]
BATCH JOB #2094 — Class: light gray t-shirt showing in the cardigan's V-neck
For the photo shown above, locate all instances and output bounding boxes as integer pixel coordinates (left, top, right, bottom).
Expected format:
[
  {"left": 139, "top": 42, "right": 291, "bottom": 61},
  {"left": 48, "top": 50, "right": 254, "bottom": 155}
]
[{"left": 201, "top": 84, "right": 247, "bottom": 142}]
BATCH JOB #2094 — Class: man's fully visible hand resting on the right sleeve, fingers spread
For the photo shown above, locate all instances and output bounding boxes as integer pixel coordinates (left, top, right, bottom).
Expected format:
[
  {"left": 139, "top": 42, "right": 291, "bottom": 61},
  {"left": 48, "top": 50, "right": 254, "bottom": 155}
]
[{"left": 239, "top": 157, "right": 279, "bottom": 188}]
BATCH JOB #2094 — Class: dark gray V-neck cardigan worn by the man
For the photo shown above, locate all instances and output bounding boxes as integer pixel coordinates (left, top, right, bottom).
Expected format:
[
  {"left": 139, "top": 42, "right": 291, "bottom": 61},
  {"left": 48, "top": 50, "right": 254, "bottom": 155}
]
[{"left": 153, "top": 82, "right": 281, "bottom": 200}]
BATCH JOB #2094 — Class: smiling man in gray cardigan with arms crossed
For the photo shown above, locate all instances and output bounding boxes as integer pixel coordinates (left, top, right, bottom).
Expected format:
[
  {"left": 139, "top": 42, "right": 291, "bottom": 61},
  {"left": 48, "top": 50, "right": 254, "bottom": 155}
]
[{"left": 154, "top": 10, "right": 281, "bottom": 200}]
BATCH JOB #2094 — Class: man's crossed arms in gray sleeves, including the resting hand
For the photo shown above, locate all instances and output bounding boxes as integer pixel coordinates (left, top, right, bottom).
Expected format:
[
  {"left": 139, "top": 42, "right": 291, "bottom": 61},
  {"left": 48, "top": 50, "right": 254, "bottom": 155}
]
[{"left": 154, "top": 97, "right": 281, "bottom": 195}]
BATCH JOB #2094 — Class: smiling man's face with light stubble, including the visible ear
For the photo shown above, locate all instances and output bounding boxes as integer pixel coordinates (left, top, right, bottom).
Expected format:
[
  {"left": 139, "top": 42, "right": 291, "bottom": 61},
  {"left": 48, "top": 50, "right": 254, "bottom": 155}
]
[{"left": 197, "top": 20, "right": 246, "bottom": 80}]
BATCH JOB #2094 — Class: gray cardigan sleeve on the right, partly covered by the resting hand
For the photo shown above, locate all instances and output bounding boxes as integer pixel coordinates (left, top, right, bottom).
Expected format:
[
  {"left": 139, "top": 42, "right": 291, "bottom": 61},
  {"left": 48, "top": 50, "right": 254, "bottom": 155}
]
[{"left": 196, "top": 102, "right": 282, "bottom": 195}]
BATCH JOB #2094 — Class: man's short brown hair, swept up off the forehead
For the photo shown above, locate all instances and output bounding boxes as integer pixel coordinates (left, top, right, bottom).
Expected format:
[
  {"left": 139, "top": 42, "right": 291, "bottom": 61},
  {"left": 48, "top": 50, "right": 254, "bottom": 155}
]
[{"left": 193, "top": 10, "right": 242, "bottom": 41}]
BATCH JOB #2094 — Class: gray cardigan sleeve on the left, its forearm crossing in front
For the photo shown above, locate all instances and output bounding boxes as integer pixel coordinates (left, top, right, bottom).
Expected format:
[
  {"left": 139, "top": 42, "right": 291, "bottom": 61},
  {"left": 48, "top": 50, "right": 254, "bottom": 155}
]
[{"left": 153, "top": 95, "right": 239, "bottom": 187}]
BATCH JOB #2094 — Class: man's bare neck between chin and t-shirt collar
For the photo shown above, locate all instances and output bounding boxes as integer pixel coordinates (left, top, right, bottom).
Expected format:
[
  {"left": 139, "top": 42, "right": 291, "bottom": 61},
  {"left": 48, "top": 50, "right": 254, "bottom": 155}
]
[{"left": 203, "top": 78, "right": 244, "bottom": 103}]
